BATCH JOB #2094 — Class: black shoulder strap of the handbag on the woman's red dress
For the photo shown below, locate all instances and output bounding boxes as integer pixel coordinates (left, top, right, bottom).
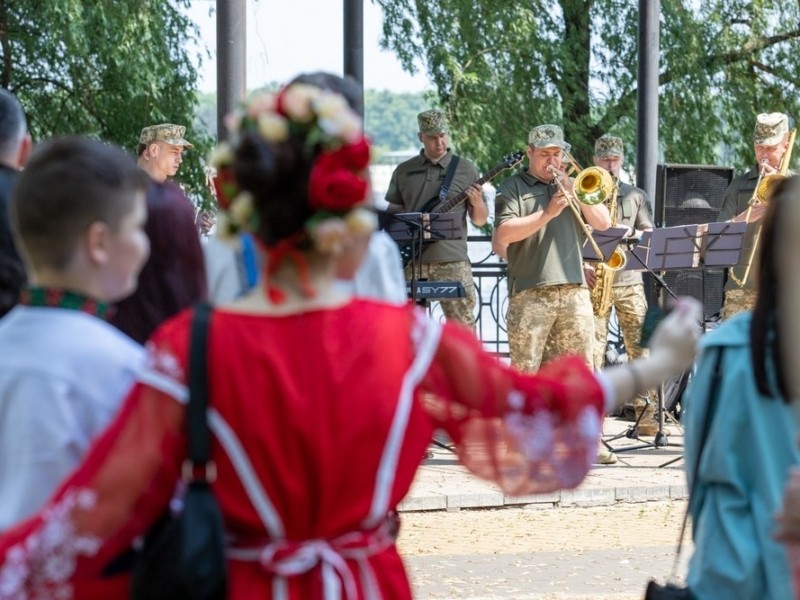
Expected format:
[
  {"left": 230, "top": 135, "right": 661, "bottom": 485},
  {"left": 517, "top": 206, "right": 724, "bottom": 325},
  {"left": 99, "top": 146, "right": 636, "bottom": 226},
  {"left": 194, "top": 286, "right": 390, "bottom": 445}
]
[{"left": 184, "top": 303, "right": 216, "bottom": 483}]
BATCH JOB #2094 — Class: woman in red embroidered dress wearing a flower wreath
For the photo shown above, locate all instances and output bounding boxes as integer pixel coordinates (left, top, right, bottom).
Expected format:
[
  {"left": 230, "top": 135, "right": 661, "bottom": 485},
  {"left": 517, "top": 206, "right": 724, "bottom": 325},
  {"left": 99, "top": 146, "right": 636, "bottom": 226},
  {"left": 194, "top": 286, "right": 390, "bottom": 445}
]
[{"left": 0, "top": 79, "right": 699, "bottom": 600}]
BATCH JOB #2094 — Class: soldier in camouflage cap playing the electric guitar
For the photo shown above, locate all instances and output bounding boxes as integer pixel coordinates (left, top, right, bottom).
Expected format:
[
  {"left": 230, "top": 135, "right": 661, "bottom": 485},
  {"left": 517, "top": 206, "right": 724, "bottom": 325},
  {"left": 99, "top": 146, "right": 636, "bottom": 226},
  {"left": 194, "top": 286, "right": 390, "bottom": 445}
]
[{"left": 386, "top": 110, "right": 489, "bottom": 329}]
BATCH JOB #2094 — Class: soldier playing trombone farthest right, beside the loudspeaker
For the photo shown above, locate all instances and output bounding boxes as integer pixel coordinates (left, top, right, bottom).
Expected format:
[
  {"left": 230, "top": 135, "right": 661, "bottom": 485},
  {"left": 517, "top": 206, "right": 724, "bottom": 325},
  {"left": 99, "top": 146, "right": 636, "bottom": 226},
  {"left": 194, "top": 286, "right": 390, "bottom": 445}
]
[{"left": 718, "top": 113, "right": 790, "bottom": 319}]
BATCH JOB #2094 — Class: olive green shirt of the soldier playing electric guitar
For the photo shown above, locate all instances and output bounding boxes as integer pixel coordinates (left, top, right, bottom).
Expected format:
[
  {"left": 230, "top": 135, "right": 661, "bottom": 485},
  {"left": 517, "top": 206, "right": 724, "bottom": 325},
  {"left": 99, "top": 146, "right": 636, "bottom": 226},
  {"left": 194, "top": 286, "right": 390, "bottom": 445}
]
[{"left": 386, "top": 149, "right": 479, "bottom": 263}]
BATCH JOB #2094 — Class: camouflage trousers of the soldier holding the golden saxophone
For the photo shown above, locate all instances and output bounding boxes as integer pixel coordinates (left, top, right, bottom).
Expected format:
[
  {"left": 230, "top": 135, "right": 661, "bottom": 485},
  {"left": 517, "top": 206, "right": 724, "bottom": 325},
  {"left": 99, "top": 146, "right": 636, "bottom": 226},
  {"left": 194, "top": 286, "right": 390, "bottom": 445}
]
[{"left": 594, "top": 283, "right": 647, "bottom": 369}]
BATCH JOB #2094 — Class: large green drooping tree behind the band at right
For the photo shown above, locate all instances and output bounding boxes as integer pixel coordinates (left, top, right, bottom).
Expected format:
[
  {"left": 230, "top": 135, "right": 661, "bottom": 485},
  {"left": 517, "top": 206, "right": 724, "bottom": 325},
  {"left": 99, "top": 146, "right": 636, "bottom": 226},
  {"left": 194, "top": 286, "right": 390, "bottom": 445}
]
[{"left": 375, "top": 0, "right": 800, "bottom": 168}]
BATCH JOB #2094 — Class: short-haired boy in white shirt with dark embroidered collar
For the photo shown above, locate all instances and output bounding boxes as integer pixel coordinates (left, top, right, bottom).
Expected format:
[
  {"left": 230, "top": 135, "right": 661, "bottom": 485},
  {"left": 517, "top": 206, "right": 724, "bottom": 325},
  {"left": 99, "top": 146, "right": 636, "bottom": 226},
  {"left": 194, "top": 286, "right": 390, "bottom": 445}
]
[{"left": 0, "top": 137, "right": 149, "bottom": 531}]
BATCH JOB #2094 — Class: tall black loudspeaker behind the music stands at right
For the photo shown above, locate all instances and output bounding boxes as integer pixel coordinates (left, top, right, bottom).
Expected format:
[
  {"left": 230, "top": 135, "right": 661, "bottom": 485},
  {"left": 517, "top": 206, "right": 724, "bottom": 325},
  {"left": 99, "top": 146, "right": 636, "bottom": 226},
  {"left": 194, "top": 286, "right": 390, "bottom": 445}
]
[{"left": 647, "top": 164, "right": 733, "bottom": 319}]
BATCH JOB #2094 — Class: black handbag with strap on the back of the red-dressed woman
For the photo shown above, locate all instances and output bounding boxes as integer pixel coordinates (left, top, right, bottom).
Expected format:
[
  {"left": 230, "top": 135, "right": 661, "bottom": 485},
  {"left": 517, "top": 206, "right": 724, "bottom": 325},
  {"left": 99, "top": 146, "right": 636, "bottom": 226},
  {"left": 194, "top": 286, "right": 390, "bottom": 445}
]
[{"left": 131, "top": 304, "right": 228, "bottom": 600}]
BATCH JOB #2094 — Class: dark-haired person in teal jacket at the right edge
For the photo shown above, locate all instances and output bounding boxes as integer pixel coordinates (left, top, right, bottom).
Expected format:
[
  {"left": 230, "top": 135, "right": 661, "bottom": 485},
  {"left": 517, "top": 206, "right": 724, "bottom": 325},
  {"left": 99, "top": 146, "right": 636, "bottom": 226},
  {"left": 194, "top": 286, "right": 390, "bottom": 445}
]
[{"left": 683, "top": 177, "right": 800, "bottom": 600}]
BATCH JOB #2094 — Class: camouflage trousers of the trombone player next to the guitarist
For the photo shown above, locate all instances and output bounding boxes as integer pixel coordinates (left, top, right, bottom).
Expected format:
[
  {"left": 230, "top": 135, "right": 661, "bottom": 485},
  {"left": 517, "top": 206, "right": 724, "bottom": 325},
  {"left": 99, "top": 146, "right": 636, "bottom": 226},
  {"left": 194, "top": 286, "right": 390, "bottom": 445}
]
[{"left": 506, "top": 284, "right": 594, "bottom": 371}]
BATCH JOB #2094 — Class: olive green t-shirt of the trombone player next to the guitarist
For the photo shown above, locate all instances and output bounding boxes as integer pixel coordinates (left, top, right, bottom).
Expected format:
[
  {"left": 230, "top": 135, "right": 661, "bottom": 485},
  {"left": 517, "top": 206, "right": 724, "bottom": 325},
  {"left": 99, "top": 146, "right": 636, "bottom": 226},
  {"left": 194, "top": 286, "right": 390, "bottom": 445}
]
[{"left": 494, "top": 170, "right": 586, "bottom": 296}]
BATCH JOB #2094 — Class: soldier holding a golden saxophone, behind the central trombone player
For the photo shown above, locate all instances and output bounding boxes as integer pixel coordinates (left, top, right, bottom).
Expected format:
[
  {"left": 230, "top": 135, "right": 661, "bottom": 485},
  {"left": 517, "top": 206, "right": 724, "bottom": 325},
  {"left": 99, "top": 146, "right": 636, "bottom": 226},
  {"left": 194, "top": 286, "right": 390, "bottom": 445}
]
[{"left": 583, "top": 135, "right": 658, "bottom": 435}]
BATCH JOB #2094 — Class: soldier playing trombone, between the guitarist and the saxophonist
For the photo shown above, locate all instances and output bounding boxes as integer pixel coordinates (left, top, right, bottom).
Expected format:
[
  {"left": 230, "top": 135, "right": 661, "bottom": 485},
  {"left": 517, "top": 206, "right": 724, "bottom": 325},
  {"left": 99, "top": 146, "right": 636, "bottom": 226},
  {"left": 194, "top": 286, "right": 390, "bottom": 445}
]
[{"left": 495, "top": 125, "right": 611, "bottom": 371}]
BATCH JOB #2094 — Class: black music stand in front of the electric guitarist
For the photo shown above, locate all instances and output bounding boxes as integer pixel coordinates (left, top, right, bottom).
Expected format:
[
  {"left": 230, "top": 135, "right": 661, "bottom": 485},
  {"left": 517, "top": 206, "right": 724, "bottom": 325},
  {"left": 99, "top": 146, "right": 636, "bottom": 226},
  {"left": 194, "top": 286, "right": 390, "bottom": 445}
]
[{"left": 384, "top": 213, "right": 463, "bottom": 306}]
